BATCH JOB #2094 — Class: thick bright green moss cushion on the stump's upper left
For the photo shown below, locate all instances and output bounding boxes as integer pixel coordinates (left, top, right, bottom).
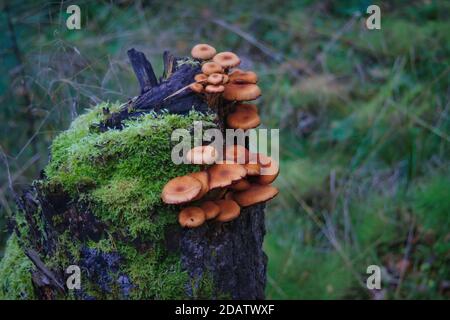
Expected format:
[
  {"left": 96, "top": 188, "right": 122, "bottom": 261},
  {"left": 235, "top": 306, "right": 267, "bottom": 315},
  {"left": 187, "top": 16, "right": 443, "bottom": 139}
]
[{"left": 45, "top": 104, "right": 211, "bottom": 240}]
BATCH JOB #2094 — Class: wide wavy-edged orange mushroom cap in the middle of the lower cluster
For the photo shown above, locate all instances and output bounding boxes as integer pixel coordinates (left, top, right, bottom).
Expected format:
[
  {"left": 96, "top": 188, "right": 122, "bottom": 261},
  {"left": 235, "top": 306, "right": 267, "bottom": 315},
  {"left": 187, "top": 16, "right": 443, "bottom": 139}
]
[{"left": 208, "top": 163, "right": 247, "bottom": 189}]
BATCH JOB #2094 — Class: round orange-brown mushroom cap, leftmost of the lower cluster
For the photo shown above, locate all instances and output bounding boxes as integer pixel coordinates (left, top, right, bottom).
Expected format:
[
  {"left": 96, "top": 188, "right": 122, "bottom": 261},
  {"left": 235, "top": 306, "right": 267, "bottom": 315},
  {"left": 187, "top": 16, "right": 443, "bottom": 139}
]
[{"left": 161, "top": 175, "right": 202, "bottom": 204}]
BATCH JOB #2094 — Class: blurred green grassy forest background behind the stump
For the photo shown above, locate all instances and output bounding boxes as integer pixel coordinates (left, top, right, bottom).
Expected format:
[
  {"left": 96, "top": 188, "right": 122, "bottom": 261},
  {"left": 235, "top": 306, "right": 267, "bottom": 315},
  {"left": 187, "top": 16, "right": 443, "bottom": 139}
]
[{"left": 0, "top": 0, "right": 450, "bottom": 299}]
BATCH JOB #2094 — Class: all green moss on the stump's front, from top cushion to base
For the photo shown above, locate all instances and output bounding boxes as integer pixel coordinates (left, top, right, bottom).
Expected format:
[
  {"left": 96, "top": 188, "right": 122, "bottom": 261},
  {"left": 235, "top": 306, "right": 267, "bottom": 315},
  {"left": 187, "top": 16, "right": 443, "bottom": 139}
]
[{"left": 3, "top": 103, "right": 218, "bottom": 299}]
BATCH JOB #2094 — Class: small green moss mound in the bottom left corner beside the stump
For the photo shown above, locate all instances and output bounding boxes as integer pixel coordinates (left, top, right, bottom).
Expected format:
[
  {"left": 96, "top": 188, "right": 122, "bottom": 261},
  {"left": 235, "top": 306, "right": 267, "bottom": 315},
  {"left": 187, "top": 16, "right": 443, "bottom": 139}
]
[{"left": 0, "top": 234, "right": 36, "bottom": 300}]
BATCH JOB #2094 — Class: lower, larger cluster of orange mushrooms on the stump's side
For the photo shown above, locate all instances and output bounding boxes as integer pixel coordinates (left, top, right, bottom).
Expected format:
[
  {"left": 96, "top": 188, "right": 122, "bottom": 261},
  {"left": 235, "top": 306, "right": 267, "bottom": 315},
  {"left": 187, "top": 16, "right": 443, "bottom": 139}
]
[{"left": 161, "top": 145, "right": 279, "bottom": 228}]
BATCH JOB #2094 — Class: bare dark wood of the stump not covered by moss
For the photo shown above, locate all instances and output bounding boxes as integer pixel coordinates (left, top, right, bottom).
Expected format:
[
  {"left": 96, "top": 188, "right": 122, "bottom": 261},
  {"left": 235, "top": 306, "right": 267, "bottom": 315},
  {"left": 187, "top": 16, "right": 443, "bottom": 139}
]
[{"left": 8, "top": 49, "right": 267, "bottom": 299}]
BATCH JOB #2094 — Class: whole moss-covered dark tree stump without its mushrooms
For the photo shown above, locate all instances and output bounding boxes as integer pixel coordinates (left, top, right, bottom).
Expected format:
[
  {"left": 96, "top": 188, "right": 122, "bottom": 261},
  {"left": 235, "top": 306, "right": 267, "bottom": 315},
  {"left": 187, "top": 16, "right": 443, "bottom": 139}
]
[{"left": 0, "top": 49, "right": 267, "bottom": 299}]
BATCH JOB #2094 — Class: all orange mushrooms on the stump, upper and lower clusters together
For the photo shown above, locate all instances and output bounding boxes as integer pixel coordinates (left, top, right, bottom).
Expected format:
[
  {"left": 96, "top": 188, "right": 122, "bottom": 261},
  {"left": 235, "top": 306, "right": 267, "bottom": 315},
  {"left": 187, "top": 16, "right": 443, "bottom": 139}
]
[{"left": 161, "top": 44, "right": 279, "bottom": 228}]
